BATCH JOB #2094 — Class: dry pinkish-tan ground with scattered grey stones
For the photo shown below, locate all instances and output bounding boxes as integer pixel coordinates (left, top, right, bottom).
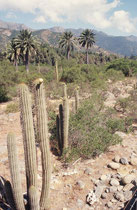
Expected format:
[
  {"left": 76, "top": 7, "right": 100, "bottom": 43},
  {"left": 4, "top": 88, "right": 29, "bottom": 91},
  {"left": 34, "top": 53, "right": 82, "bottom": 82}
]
[{"left": 0, "top": 80, "right": 137, "bottom": 210}]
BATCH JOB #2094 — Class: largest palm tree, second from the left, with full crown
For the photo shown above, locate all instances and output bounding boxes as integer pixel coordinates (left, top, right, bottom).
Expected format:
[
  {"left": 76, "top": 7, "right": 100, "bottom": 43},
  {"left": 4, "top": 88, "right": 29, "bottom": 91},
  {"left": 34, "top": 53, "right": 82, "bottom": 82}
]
[{"left": 15, "top": 30, "right": 39, "bottom": 73}]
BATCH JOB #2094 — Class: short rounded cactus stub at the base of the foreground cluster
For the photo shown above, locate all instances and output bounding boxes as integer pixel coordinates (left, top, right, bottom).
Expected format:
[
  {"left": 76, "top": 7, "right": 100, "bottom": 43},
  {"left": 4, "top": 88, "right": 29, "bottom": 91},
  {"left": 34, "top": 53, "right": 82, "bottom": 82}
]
[{"left": 29, "top": 186, "right": 40, "bottom": 210}]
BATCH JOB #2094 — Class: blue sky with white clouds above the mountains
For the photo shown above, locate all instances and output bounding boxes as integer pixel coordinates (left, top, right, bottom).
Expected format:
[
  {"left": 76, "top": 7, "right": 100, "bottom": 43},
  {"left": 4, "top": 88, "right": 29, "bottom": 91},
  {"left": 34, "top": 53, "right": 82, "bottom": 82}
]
[{"left": 0, "top": 0, "right": 137, "bottom": 35}]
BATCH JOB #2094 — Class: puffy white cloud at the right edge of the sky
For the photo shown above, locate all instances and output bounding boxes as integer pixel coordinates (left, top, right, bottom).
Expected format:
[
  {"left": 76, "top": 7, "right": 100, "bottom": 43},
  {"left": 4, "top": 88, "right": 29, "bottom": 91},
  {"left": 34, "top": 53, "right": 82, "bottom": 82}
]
[{"left": 110, "top": 10, "right": 137, "bottom": 33}]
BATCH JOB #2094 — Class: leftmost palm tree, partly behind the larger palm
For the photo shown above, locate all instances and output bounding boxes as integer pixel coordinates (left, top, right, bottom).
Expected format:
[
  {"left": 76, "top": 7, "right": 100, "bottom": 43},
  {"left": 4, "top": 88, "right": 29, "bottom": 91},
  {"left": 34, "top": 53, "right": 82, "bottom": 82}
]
[{"left": 6, "top": 38, "right": 20, "bottom": 71}]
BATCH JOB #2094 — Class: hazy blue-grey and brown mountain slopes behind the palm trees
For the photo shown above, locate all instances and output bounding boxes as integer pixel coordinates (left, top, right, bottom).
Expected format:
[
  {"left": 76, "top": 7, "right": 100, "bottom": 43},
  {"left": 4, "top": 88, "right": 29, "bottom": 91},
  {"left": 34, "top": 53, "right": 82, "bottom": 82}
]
[{"left": 0, "top": 21, "right": 137, "bottom": 56}]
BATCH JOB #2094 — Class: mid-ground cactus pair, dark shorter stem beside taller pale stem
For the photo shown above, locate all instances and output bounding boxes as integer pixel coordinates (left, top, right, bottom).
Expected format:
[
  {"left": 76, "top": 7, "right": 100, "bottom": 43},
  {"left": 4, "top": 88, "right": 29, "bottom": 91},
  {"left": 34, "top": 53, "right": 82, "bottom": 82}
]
[{"left": 56, "top": 84, "right": 69, "bottom": 154}]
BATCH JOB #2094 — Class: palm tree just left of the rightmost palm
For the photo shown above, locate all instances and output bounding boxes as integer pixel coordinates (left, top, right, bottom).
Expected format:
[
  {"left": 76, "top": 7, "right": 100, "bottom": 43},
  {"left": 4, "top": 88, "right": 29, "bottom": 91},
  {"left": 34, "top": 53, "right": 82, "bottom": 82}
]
[{"left": 59, "top": 31, "right": 74, "bottom": 60}]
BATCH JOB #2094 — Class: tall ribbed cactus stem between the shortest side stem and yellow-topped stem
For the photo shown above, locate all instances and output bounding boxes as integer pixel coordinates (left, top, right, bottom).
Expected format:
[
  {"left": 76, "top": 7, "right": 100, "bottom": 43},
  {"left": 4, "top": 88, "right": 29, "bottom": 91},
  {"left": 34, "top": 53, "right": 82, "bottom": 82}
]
[{"left": 19, "top": 84, "right": 37, "bottom": 194}]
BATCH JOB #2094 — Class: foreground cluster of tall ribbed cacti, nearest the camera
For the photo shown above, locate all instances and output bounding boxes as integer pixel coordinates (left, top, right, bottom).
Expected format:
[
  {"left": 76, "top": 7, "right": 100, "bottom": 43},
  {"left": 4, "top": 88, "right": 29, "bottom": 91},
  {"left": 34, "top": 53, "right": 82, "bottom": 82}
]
[{"left": 7, "top": 79, "right": 51, "bottom": 210}]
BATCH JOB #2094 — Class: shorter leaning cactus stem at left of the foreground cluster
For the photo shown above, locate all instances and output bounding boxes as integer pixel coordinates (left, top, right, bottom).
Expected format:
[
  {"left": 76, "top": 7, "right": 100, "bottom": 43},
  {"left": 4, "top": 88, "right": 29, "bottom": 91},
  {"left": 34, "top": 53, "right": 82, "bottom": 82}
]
[{"left": 7, "top": 133, "right": 25, "bottom": 210}]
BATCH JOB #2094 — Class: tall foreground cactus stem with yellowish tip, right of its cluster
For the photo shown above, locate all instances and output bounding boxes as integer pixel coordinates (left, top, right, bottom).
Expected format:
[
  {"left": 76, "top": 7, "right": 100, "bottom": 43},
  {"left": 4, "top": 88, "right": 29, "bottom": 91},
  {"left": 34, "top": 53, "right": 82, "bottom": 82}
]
[{"left": 35, "top": 80, "right": 51, "bottom": 210}]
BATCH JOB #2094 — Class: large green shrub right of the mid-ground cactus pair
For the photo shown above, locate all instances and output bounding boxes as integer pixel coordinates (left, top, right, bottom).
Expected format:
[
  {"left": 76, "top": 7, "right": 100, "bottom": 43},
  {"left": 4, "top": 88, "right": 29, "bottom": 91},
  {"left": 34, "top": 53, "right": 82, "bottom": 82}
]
[{"left": 67, "top": 94, "right": 132, "bottom": 161}]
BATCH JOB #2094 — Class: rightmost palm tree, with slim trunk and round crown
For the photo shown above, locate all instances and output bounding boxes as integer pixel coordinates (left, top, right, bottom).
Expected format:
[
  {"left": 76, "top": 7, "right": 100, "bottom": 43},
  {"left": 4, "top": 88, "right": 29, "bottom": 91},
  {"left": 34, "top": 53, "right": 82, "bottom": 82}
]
[{"left": 78, "top": 29, "right": 95, "bottom": 64}]
